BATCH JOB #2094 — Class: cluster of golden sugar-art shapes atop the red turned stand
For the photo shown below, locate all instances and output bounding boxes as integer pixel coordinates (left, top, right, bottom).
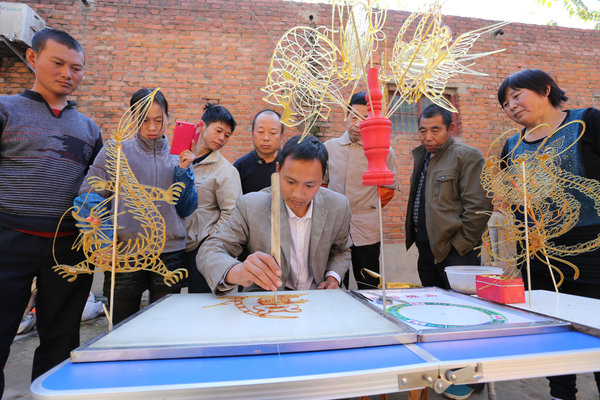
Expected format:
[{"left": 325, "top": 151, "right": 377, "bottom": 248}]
[{"left": 261, "top": 0, "right": 507, "bottom": 140}]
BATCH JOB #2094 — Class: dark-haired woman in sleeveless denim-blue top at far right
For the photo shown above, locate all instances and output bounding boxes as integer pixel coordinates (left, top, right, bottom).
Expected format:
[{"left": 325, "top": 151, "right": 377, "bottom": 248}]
[{"left": 498, "top": 69, "right": 600, "bottom": 400}]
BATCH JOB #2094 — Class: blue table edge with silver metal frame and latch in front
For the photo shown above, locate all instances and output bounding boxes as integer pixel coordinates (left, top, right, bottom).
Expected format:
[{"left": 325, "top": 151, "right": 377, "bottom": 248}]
[{"left": 31, "top": 329, "right": 600, "bottom": 399}]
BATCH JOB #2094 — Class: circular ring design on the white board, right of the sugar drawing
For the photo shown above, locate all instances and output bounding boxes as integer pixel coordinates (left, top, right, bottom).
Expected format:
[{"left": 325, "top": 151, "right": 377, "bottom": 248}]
[{"left": 387, "top": 302, "right": 507, "bottom": 328}]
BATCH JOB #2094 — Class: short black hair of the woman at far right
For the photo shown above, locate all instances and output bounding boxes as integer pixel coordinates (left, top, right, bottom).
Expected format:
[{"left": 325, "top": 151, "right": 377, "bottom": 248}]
[{"left": 498, "top": 69, "right": 569, "bottom": 107}]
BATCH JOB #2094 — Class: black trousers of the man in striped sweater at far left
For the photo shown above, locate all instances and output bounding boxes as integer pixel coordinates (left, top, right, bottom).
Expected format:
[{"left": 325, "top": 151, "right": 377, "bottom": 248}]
[{"left": 0, "top": 227, "right": 92, "bottom": 397}]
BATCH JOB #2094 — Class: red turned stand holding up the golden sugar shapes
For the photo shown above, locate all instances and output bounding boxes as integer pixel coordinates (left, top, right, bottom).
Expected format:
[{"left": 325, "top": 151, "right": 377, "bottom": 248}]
[{"left": 360, "top": 68, "right": 394, "bottom": 186}]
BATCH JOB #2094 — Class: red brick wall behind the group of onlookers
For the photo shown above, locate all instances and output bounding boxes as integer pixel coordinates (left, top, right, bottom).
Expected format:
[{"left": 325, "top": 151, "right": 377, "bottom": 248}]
[{"left": 0, "top": 0, "right": 600, "bottom": 242}]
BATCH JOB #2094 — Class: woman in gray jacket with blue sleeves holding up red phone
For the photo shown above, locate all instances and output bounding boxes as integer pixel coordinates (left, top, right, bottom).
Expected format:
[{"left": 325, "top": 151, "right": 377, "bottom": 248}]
[{"left": 76, "top": 89, "right": 198, "bottom": 324}]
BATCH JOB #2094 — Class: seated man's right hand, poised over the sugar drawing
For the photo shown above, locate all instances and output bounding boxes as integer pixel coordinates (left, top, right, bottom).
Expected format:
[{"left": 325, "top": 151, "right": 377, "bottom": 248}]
[{"left": 225, "top": 251, "right": 281, "bottom": 291}]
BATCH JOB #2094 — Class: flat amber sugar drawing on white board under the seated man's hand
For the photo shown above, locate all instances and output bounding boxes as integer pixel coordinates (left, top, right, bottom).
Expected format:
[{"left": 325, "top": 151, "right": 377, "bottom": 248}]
[{"left": 203, "top": 293, "right": 308, "bottom": 319}]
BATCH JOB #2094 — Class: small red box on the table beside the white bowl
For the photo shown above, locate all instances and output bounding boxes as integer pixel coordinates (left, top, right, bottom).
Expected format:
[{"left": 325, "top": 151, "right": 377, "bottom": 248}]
[{"left": 475, "top": 275, "right": 525, "bottom": 304}]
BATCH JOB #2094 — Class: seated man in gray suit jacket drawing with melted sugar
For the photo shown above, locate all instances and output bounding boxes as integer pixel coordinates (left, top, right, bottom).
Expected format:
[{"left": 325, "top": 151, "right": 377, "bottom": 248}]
[{"left": 196, "top": 136, "right": 351, "bottom": 294}]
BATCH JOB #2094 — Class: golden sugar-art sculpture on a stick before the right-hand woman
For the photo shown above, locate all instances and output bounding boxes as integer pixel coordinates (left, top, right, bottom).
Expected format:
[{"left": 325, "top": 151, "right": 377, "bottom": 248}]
[{"left": 481, "top": 121, "right": 600, "bottom": 287}]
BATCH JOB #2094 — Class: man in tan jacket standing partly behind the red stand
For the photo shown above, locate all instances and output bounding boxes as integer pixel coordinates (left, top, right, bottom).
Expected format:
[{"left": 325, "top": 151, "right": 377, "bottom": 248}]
[{"left": 324, "top": 92, "right": 396, "bottom": 289}]
